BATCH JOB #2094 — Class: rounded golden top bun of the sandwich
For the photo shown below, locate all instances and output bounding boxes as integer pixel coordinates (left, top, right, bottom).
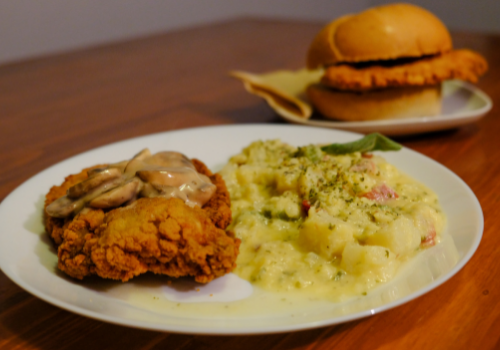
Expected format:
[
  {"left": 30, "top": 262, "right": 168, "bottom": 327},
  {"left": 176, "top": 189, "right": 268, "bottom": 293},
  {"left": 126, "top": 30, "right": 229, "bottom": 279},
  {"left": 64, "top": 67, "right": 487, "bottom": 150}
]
[{"left": 307, "top": 4, "right": 453, "bottom": 69}]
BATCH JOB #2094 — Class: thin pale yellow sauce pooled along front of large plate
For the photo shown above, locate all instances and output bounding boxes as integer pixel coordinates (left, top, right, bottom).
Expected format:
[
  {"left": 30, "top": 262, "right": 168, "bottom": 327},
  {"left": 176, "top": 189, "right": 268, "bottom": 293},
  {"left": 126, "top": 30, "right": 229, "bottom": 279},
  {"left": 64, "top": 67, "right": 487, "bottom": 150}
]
[{"left": 104, "top": 235, "right": 459, "bottom": 324}]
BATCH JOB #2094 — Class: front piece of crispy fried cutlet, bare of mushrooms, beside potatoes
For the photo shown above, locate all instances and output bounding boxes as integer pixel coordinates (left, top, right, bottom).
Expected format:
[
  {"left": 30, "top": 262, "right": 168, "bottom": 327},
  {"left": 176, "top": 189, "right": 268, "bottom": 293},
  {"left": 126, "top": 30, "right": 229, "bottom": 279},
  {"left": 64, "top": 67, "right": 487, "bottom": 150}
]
[{"left": 89, "top": 198, "right": 239, "bottom": 283}]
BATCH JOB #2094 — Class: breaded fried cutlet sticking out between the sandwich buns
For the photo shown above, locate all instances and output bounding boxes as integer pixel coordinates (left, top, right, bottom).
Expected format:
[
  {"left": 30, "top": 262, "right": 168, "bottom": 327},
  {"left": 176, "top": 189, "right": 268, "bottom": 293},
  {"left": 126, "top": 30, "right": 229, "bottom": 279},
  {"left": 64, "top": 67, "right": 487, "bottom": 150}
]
[{"left": 321, "top": 49, "right": 488, "bottom": 91}]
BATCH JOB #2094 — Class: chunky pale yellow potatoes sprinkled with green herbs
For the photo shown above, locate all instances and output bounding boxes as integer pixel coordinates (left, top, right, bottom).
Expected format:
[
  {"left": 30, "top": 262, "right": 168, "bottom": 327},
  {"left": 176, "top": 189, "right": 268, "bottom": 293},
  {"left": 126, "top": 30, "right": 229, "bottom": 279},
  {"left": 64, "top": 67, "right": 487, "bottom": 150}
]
[{"left": 221, "top": 140, "right": 445, "bottom": 299}]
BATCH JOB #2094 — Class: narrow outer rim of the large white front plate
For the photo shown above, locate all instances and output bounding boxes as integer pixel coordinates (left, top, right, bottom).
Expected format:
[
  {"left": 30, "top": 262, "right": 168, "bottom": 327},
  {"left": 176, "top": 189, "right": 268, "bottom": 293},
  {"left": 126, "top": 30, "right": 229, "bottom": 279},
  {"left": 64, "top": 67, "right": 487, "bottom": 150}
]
[{"left": 0, "top": 124, "right": 484, "bottom": 335}]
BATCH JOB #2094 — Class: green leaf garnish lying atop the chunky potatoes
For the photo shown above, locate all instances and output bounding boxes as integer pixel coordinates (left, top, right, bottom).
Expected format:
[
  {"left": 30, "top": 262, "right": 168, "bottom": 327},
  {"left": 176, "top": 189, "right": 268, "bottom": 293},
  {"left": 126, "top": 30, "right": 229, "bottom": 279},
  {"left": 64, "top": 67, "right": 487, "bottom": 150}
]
[{"left": 321, "top": 132, "right": 402, "bottom": 154}]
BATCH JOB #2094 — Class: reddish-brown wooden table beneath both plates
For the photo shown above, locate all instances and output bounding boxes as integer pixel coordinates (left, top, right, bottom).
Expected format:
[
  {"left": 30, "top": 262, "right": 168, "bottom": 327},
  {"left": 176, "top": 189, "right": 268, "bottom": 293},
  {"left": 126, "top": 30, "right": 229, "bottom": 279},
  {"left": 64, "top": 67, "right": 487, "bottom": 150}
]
[{"left": 0, "top": 19, "right": 500, "bottom": 350}]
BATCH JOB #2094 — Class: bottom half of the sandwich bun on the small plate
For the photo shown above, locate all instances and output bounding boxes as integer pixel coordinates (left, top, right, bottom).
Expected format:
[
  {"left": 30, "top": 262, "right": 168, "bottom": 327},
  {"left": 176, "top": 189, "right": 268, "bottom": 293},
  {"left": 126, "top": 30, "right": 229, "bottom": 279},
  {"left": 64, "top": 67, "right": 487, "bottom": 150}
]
[{"left": 307, "top": 84, "right": 441, "bottom": 121}]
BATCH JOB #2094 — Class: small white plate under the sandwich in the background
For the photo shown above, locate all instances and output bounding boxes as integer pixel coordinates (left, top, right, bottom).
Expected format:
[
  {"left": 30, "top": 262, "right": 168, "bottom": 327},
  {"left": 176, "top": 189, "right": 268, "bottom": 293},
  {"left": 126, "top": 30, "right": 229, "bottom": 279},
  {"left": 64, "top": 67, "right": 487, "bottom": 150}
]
[{"left": 281, "top": 80, "right": 492, "bottom": 136}]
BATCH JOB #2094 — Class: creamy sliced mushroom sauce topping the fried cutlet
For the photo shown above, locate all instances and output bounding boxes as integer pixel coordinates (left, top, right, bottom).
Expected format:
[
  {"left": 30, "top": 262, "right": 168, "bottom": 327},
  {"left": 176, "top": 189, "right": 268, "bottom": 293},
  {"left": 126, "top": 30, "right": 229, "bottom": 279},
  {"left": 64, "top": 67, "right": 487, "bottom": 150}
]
[{"left": 46, "top": 149, "right": 216, "bottom": 218}]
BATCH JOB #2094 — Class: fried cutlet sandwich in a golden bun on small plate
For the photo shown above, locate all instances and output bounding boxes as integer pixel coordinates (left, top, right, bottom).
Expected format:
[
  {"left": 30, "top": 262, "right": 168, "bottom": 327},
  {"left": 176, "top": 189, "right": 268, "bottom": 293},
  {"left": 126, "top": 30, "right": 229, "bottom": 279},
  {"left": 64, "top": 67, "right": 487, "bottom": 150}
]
[{"left": 307, "top": 3, "right": 488, "bottom": 121}]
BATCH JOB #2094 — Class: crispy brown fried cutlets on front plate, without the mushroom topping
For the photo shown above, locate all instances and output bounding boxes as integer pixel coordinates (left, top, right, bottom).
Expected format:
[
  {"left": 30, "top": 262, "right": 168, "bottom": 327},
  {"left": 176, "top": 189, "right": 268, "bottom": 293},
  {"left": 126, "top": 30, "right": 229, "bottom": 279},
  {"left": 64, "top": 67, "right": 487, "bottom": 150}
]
[{"left": 45, "top": 160, "right": 240, "bottom": 283}]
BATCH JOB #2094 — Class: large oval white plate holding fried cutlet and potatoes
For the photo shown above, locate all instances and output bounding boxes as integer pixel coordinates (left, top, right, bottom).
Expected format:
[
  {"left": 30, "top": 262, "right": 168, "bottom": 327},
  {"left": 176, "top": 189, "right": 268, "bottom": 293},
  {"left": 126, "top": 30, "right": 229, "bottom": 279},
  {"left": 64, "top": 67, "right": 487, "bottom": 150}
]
[{"left": 0, "top": 125, "right": 483, "bottom": 334}]
